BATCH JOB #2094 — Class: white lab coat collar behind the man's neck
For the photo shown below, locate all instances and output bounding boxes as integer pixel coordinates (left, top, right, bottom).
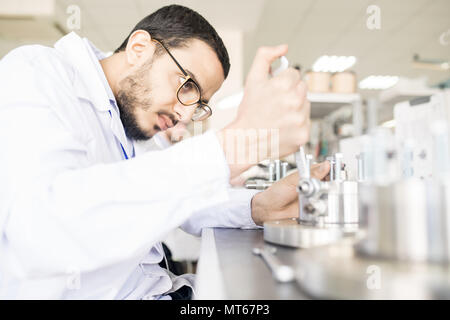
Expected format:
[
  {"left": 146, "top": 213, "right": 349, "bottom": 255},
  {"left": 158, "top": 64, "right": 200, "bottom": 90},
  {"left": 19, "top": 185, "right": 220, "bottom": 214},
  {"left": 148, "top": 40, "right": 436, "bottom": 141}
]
[{"left": 55, "top": 32, "right": 114, "bottom": 111}]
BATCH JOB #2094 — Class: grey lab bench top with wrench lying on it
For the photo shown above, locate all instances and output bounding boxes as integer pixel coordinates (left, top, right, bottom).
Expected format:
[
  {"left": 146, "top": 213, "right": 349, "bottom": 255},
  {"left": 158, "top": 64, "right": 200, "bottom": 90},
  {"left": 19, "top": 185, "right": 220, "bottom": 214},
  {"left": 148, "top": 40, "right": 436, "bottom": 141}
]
[{"left": 197, "top": 228, "right": 309, "bottom": 300}]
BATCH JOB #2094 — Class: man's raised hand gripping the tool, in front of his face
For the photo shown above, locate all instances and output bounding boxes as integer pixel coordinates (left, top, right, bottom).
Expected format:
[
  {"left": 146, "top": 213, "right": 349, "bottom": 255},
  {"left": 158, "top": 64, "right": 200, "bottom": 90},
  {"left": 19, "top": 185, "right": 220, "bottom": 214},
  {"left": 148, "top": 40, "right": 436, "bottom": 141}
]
[{"left": 218, "top": 45, "right": 310, "bottom": 178}]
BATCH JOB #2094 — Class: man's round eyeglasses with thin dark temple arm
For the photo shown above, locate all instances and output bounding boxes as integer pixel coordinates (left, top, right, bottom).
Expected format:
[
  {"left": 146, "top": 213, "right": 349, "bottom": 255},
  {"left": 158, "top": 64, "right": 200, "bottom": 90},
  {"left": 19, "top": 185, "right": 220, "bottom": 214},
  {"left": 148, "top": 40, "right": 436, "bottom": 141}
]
[{"left": 152, "top": 39, "right": 212, "bottom": 121}]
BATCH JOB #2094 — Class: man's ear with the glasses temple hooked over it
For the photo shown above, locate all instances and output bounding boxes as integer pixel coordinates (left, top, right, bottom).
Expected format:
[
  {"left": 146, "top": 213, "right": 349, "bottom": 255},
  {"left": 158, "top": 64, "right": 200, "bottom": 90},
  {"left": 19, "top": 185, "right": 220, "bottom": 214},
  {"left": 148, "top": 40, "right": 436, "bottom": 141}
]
[{"left": 125, "top": 30, "right": 155, "bottom": 65}]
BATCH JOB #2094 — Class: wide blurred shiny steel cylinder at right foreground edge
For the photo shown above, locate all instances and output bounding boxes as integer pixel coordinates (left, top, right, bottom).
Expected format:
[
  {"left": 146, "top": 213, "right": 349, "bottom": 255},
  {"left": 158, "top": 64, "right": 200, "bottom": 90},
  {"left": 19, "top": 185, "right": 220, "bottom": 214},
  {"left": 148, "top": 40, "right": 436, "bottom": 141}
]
[{"left": 357, "top": 178, "right": 450, "bottom": 262}]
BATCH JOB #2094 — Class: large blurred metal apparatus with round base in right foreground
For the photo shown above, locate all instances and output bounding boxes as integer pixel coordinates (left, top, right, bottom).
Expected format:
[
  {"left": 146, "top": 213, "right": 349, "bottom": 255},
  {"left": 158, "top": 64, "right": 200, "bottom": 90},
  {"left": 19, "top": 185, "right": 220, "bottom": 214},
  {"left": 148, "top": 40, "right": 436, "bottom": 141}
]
[{"left": 296, "top": 91, "right": 450, "bottom": 299}]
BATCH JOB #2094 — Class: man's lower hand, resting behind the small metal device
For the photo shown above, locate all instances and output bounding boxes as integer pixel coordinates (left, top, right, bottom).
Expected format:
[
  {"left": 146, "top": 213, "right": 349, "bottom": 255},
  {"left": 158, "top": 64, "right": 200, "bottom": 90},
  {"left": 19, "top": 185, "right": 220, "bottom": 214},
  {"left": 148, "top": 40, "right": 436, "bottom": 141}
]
[{"left": 251, "top": 161, "right": 330, "bottom": 225}]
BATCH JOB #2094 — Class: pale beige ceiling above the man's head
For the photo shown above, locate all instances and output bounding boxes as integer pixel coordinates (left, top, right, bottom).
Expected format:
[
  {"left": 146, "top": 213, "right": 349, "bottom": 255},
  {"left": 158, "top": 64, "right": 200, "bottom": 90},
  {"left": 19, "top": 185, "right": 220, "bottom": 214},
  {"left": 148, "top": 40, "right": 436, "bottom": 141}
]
[{"left": 0, "top": 0, "right": 450, "bottom": 94}]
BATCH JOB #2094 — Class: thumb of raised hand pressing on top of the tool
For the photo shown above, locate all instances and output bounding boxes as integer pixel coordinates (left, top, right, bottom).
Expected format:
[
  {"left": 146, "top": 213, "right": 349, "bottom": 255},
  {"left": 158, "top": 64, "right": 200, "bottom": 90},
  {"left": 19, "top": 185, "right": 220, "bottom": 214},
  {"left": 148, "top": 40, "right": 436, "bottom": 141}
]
[{"left": 247, "top": 44, "right": 288, "bottom": 83}]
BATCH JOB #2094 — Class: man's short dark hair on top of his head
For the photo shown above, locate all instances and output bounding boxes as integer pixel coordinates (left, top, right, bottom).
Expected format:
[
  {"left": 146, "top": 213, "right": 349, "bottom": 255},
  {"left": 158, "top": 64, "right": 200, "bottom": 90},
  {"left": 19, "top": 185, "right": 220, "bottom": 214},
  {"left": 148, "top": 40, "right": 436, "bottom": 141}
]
[{"left": 115, "top": 5, "right": 230, "bottom": 78}]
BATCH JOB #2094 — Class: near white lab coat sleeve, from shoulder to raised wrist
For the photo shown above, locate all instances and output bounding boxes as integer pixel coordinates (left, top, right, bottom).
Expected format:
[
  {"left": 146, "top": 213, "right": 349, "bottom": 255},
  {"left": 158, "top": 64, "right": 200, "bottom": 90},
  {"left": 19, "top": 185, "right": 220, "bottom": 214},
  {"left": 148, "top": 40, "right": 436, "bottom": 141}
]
[{"left": 0, "top": 46, "right": 237, "bottom": 279}]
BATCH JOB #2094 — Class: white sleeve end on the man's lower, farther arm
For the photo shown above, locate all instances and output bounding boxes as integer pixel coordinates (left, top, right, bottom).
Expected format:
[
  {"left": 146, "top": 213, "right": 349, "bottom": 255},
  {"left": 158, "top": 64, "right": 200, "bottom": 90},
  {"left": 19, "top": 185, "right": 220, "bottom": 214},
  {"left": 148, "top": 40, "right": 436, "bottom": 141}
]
[{"left": 181, "top": 188, "right": 260, "bottom": 236}]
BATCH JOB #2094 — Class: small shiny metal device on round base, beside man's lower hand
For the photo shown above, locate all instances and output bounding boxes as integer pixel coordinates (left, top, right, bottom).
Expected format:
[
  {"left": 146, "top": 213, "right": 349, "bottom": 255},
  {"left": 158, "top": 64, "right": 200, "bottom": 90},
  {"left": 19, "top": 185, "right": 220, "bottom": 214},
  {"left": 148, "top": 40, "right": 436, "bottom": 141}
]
[{"left": 264, "top": 148, "right": 358, "bottom": 248}]
